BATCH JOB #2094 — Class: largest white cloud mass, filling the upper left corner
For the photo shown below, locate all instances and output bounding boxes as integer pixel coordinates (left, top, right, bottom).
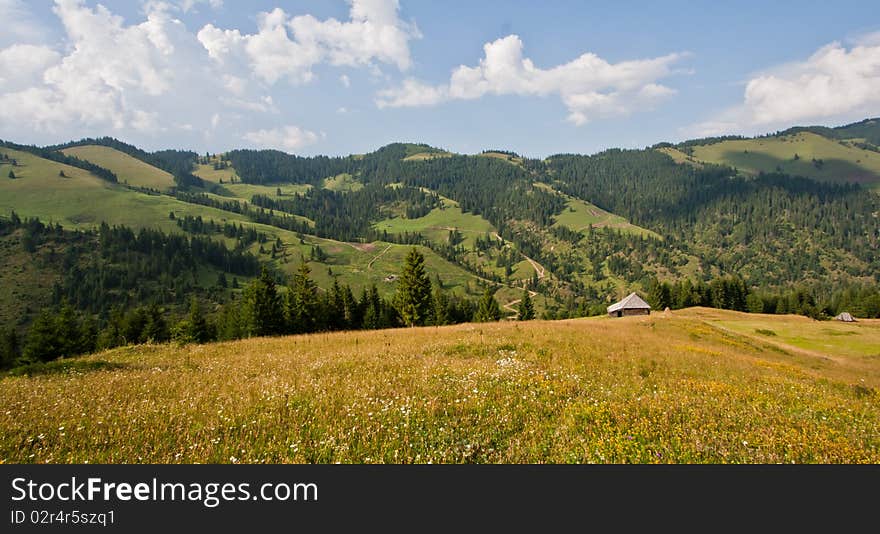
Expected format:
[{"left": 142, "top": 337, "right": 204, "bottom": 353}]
[{"left": 0, "top": 0, "right": 310, "bottom": 146}]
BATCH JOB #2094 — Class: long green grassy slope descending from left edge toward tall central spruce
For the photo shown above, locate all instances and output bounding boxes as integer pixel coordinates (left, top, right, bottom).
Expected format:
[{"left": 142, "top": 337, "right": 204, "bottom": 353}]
[{"left": 0, "top": 149, "right": 482, "bottom": 300}]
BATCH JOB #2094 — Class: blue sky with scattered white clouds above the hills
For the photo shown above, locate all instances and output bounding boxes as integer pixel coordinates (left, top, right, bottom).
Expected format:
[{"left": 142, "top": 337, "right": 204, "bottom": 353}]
[{"left": 0, "top": 0, "right": 880, "bottom": 157}]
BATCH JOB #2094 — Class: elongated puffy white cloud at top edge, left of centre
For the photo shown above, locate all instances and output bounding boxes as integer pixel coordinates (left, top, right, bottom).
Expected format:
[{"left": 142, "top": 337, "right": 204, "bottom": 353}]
[{"left": 198, "top": 0, "right": 420, "bottom": 84}]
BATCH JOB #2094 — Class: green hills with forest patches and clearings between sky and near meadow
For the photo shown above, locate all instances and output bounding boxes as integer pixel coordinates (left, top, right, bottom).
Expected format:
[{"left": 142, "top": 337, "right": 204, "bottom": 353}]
[{"left": 0, "top": 121, "right": 880, "bottom": 366}]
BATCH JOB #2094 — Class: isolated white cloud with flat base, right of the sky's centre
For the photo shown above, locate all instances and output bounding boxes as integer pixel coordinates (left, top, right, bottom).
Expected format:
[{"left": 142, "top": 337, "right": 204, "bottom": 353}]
[{"left": 376, "top": 35, "right": 683, "bottom": 125}]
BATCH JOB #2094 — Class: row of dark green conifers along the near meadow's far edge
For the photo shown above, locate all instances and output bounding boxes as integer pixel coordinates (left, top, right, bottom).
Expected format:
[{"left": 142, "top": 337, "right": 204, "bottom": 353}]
[{"left": 0, "top": 248, "right": 520, "bottom": 368}]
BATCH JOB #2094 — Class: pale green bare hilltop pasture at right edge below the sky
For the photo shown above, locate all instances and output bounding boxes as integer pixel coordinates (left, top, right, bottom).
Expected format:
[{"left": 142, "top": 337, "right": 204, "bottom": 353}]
[{"left": 694, "top": 132, "right": 880, "bottom": 185}]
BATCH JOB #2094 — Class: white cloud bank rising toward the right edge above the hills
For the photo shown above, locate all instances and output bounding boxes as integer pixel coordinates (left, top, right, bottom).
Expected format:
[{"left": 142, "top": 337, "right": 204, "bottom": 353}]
[{"left": 685, "top": 39, "right": 880, "bottom": 136}]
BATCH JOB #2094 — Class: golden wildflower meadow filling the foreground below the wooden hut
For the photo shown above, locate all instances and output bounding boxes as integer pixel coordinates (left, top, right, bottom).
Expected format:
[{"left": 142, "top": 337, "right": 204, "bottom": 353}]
[{"left": 0, "top": 309, "right": 880, "bottom": 463}]
